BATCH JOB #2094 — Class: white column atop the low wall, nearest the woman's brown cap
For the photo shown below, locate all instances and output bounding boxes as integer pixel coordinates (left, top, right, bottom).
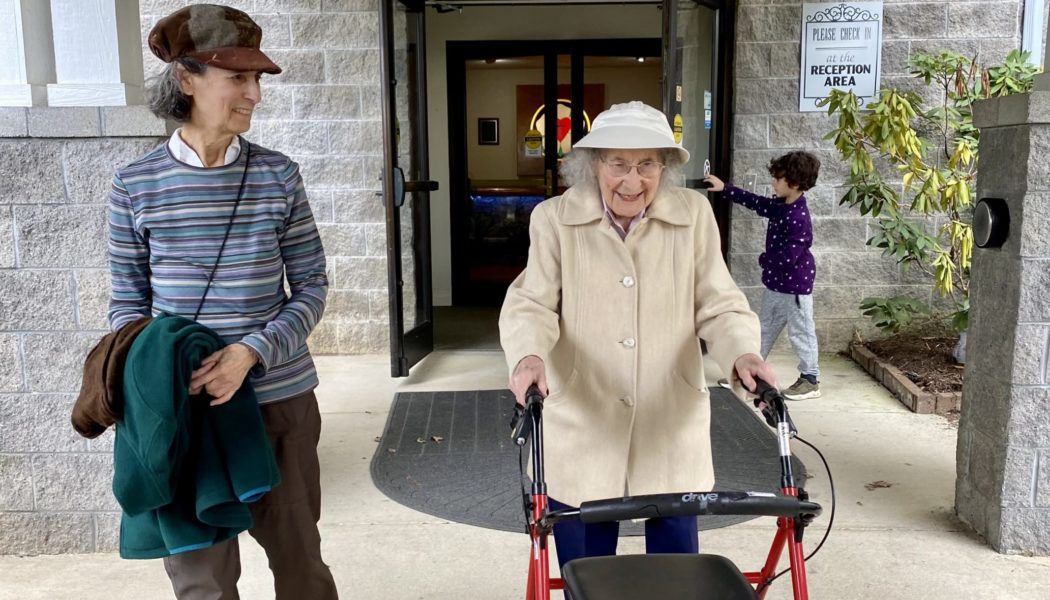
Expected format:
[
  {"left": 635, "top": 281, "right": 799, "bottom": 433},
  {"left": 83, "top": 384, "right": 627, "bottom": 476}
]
[{"left": 47, "top": 0, "right": 143, "bottom": 106}]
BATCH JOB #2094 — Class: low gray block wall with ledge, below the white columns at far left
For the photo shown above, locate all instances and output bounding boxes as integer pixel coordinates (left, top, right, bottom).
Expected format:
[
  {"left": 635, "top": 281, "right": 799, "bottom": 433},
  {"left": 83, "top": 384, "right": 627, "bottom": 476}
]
[{"left": 0, "top": 107, "right": 165, "bottom": 554}]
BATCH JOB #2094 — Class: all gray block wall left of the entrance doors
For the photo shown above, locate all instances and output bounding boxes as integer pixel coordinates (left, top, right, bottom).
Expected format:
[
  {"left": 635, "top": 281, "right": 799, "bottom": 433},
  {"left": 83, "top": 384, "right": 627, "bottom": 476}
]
[{"left": 0, "top": 0, "right": 389, "bottom": 554}]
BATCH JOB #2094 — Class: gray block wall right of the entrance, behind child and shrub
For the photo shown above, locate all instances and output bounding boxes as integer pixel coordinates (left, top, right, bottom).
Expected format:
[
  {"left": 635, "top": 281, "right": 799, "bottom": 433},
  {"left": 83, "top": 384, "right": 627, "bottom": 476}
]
[{"left": 730, "top": 0, "right": 1023, "bottom": 351}]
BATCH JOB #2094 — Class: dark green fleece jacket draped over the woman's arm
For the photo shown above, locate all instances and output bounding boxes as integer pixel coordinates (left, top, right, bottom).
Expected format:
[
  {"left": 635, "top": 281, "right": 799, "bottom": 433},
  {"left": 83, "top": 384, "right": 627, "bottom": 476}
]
[{"left": 113, "top": 315, "right": 280, "bottom": 558}]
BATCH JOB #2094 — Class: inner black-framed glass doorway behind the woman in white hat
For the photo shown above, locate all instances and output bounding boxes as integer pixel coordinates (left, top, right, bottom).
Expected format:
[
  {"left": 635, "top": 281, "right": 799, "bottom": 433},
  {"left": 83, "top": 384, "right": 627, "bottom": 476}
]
[{"left": 436, "top": 38, "right": 663, "bottom": 349}]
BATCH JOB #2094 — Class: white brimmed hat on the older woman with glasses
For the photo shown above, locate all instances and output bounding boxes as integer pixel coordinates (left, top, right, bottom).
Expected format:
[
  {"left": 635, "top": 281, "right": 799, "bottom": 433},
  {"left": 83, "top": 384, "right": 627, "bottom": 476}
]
[{"left": 572, "top": 100, "right": 689, "bottom": 164}]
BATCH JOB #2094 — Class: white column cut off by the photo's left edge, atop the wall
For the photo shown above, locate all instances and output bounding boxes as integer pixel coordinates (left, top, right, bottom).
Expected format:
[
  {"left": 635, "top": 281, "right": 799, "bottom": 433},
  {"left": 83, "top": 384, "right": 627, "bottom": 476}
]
[{"left": 0, "top": 0, "right": 55, "bottom": 106}]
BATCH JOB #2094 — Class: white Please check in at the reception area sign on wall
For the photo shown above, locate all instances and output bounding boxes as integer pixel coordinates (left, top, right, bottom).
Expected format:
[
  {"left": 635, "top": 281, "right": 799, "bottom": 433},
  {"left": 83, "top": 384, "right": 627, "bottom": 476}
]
[{"left": 798, "top": 2, "right": 882, "bottom": 112}]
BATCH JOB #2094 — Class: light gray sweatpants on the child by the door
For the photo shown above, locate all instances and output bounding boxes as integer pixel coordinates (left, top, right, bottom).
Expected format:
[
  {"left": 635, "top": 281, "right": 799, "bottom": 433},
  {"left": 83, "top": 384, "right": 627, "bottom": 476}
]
[{"left": 758, "top": 289, "right": 820, "bottom": 377}]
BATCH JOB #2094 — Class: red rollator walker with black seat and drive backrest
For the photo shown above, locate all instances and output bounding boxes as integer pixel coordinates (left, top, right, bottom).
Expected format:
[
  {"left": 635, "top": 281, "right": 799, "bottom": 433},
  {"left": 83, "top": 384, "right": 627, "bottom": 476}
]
[{"left": 511, "top": 379, "right": 835, "bottom": 600}]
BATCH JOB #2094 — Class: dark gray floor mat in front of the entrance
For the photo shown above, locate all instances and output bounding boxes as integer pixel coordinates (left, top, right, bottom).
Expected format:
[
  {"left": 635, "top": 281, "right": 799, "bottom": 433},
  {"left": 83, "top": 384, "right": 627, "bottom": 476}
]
[{"left": 372, "top": 388, "right": 805, "bottom": 535}]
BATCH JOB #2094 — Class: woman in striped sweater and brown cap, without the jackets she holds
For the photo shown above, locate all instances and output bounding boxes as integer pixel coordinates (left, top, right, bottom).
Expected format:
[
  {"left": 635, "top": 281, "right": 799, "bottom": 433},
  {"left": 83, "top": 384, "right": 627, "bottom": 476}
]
[{"left": 109, "top": 4, "right": 337, "bottom": 600}]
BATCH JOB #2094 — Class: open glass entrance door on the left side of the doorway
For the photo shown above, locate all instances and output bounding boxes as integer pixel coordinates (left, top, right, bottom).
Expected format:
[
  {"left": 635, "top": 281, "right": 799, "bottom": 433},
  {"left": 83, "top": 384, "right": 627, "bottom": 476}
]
[{"left": 380, "top": 0, "right": 437, "bottom": 377}]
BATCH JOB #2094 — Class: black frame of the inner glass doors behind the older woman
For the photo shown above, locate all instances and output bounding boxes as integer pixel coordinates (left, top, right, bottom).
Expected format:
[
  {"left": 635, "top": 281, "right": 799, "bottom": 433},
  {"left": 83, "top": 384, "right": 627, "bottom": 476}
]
[{"left": 445, "top": 38, "right": 662, "bottom": 306}]
